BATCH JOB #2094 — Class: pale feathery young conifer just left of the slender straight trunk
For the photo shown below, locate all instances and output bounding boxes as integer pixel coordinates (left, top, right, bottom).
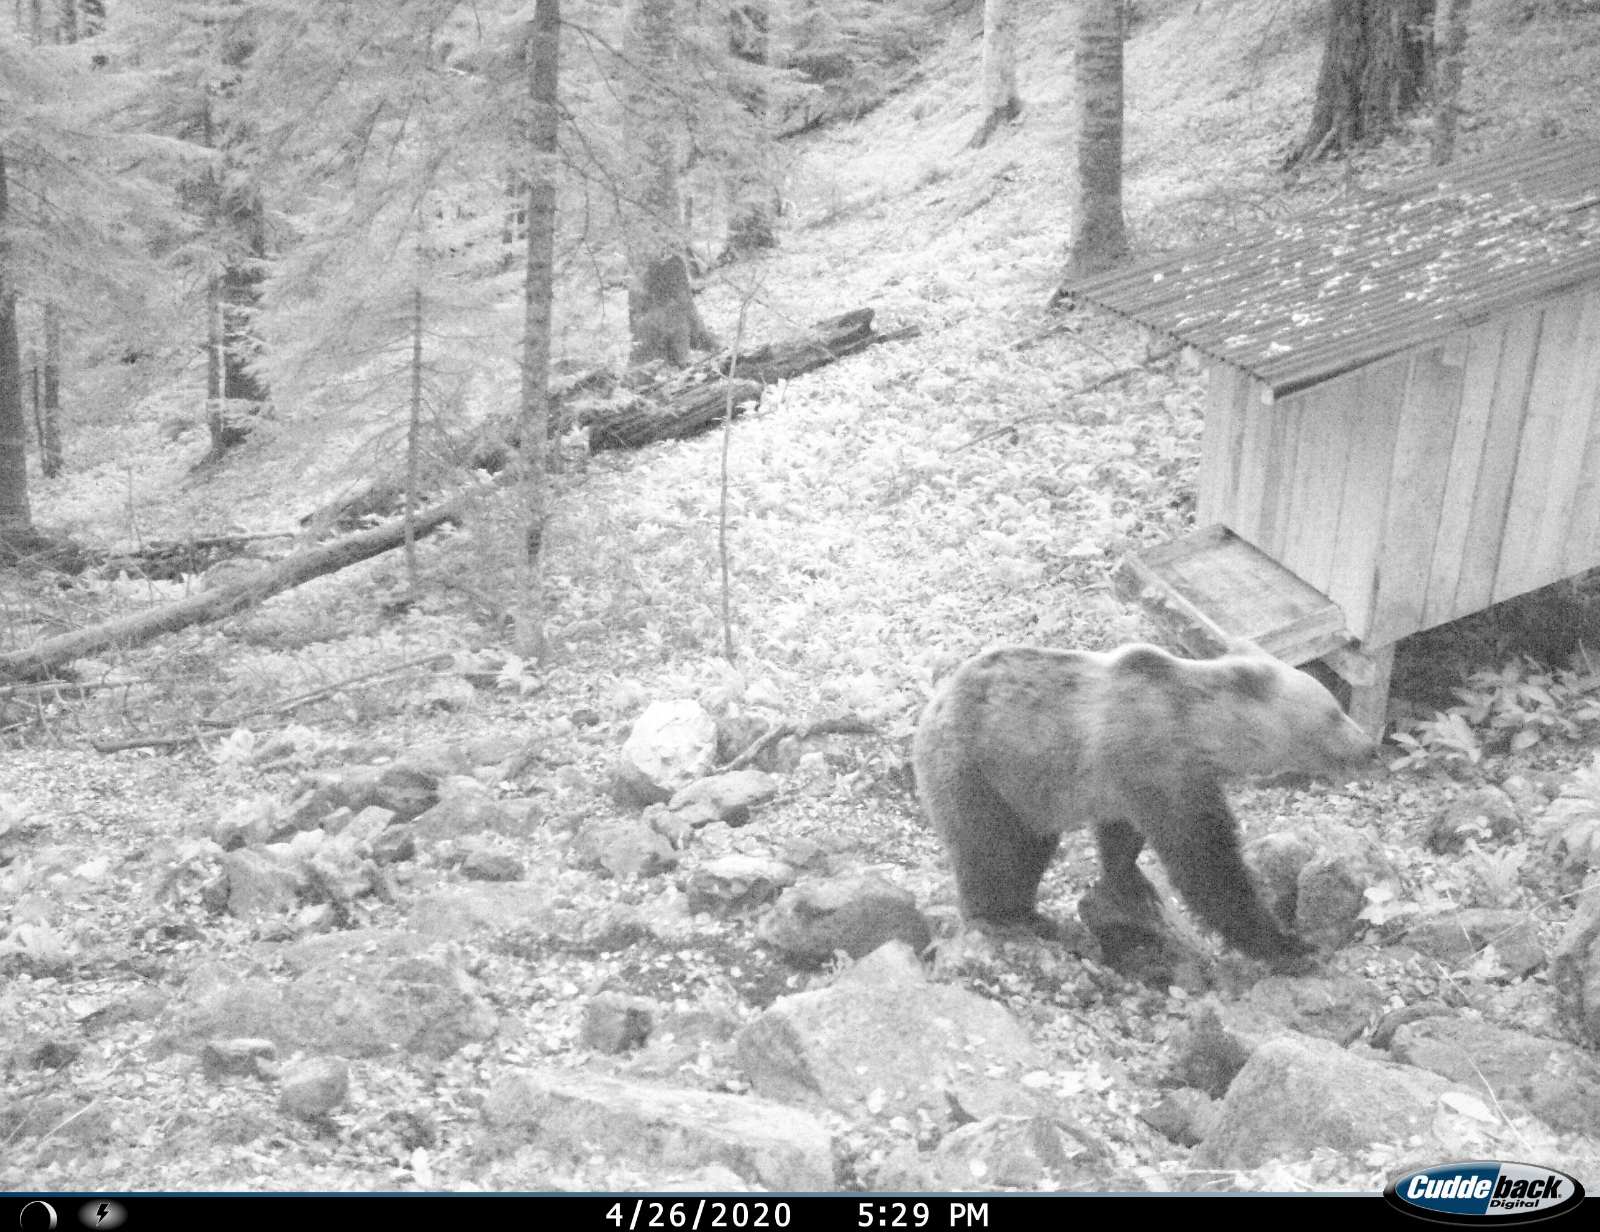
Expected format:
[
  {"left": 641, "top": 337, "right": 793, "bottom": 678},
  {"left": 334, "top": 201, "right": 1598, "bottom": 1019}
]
[{"left": 240, "top": 0, "right": 517, "bottom": 507}]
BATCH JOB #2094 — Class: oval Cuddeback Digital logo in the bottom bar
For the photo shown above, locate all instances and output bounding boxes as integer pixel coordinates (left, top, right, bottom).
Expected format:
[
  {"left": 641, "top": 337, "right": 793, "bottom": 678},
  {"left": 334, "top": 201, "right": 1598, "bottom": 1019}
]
[{"left": 1384, "top": 1160, "right": 1584, "bottom": 1224}]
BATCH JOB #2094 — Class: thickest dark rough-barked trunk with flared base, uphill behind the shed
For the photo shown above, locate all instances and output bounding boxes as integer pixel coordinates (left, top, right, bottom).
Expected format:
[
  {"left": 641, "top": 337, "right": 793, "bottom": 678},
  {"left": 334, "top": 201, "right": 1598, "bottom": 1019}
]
[{"left": 1288, "top": 0, "right": 1434, "bottom": 166}]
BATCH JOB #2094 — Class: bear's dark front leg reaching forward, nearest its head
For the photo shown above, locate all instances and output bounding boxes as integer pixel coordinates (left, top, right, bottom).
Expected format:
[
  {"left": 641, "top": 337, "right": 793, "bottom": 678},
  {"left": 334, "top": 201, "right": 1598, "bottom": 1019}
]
[{"left": 1146, "top": 790, "right": 1312, "bottom": 958}]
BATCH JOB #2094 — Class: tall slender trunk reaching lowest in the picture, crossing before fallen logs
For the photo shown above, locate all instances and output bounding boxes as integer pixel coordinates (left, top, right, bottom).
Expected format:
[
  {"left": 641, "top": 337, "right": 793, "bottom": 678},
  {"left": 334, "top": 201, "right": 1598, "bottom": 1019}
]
[{"left": 517, "top": 0, "right": 562, "bottom": 659}]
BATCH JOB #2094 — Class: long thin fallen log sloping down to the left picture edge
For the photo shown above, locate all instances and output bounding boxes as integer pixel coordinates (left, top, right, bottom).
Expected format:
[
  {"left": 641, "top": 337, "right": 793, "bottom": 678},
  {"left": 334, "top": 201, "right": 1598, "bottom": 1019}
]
[{"left": 0, "top": 493, "right": 475, "bottom": 680}]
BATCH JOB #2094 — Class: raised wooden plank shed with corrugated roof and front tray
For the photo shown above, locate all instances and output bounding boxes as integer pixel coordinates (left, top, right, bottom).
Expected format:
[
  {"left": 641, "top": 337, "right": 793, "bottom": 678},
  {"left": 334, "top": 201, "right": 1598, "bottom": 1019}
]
[{"left": 1062, "top": 139, "right": 1600, "bottom": 731}]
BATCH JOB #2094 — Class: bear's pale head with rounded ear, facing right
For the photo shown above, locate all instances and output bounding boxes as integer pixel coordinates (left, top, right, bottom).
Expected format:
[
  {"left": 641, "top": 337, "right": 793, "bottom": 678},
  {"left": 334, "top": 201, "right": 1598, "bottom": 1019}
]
[{"left": 1205, "top": 651, "right": 1378, "bottom": 778}]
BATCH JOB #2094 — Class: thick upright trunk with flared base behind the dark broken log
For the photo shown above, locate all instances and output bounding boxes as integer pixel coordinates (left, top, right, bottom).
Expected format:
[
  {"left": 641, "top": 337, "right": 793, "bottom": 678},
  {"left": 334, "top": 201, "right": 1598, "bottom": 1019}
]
[{"left": 622, "top": 0, "right": 717, "bottom": 366}]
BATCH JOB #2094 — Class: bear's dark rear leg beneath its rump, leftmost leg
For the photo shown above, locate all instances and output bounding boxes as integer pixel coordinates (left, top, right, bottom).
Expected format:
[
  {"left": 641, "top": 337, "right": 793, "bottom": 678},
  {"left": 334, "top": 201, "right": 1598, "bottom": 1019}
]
[{"left": 931, "top": 770, "right": 1061, "bottom": 923}]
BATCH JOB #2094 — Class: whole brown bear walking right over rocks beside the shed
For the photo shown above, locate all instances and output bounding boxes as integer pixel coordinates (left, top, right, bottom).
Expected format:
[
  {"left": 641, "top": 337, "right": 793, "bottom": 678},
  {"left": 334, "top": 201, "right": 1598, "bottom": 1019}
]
[{"left": 914, "top": 643, "right": 1374, "bottom": 958}]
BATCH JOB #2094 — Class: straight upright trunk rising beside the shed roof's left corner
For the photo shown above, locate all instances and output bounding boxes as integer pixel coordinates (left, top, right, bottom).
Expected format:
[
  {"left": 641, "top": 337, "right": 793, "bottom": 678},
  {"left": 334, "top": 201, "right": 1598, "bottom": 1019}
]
[{"left": 1067, "top": 0, "right": 1128, "bottom": 278}]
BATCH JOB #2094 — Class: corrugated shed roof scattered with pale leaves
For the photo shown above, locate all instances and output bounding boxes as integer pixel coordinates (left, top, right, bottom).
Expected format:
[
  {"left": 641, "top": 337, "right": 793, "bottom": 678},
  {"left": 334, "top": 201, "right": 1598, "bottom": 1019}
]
[{"left": 1061, "top": 139, "right": 1600, "bottom": 395}]
